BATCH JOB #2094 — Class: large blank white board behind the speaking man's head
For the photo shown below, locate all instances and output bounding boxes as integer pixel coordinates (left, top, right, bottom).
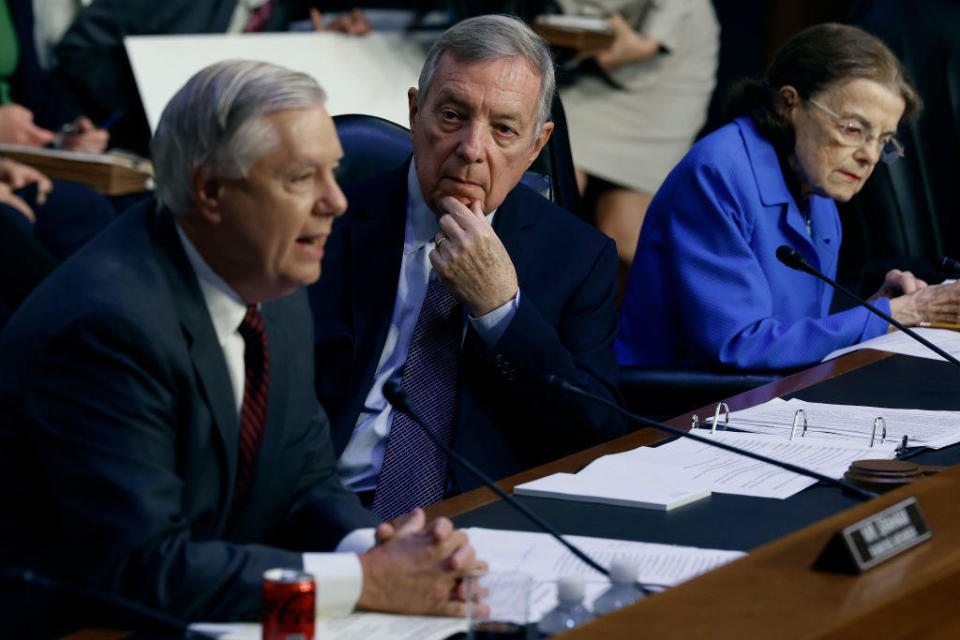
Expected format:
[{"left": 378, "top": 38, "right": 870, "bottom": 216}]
[{"left": 124, "top": 31, "right": 426, "bottom": 131}]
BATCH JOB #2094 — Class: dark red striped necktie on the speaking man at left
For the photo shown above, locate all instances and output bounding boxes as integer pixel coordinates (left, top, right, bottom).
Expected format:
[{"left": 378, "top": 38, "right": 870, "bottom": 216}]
[{"left": 231, "top": 304, "right": 270, "bottom": 513}]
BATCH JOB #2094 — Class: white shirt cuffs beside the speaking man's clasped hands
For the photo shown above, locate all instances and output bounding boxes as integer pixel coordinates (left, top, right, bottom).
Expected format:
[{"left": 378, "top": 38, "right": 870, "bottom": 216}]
[{"left": 303, "top": 528, "right": 374, "bottom": 618}]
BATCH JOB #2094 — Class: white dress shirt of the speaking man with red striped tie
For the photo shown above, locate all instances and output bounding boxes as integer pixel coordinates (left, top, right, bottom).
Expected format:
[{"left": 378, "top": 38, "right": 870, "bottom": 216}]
[{"left": 177, "top": 224, "right": 374, "bottom": 616}]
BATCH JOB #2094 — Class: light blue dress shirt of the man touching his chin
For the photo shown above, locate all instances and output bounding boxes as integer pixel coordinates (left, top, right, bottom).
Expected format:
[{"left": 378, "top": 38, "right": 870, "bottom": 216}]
[{"left": 340, "top": 160, "right": 520, "bottom": 491}]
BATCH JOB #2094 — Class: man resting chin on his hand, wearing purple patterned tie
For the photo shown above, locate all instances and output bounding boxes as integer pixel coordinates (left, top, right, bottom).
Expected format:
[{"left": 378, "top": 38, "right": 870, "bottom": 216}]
[{"left": 310, "top": 16, "right": 623, "bottom": 518}]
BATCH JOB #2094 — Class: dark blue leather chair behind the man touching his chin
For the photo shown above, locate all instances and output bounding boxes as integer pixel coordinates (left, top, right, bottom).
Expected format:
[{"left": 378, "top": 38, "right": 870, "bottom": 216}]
[{"left": 333, "top": 92, "right": 580, "bottom": 215}]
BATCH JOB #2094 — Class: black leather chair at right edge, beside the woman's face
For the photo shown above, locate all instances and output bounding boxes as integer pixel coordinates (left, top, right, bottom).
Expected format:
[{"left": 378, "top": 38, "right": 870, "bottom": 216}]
[{"left": 840, "top": 0, "right": 960, "bottom": 294}]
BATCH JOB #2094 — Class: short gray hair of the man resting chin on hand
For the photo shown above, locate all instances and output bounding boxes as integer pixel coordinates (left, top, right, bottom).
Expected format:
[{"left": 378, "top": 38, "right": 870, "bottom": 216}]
[{"left": 417, "top": 15, "right": 556, "bottom": 133}]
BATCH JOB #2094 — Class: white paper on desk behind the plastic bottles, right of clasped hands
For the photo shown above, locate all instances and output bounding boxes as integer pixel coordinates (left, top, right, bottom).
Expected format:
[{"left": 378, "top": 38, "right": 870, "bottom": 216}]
[{"left": 466, "top": 527, "right": 744, "bottom": 620}]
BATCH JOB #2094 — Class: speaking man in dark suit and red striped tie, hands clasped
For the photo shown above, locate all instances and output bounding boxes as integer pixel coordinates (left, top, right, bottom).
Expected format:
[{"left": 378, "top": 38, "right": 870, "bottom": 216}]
[{"left": 0, "top": 61, "right": 481, "bottom": 631}]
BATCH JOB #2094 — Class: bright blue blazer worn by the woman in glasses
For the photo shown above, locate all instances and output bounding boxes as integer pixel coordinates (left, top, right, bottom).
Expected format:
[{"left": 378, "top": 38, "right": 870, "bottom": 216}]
[{"left": 616, "top": 118, "right": 890, "bottom": 369}]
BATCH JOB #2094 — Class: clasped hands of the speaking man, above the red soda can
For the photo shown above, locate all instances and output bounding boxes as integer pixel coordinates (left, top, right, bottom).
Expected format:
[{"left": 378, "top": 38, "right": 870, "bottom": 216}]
[{"left": 357, "top": 509, "right": 486, "bottom": 616}]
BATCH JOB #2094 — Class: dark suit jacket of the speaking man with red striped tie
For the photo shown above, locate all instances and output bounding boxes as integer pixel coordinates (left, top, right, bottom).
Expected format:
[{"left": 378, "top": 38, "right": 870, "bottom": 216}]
[{"left": 0, "top": 202, "right": 376, "bottom": 619}]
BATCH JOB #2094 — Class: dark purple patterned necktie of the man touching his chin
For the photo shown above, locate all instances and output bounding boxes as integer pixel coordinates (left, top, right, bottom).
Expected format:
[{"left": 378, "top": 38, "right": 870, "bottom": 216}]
[{"left": 373, "top": 280, "right": 463, "bottom": 520}]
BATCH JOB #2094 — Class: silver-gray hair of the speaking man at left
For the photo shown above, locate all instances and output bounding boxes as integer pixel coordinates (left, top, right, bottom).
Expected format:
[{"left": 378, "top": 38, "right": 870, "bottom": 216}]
[{"left": 150, "top": 60, "right": 326, "bottom": 213}]
